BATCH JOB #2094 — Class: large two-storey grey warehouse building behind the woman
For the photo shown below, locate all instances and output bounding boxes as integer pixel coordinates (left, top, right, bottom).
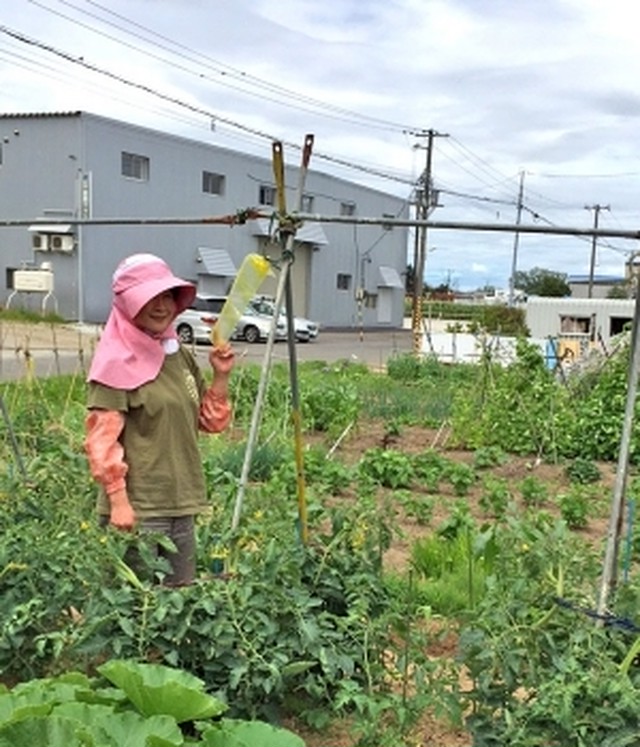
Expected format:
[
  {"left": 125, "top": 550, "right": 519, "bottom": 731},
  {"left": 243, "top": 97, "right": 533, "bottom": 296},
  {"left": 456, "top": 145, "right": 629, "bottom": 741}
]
[{"left": 0, "top": 111, "right": 409, "bottom": 328}]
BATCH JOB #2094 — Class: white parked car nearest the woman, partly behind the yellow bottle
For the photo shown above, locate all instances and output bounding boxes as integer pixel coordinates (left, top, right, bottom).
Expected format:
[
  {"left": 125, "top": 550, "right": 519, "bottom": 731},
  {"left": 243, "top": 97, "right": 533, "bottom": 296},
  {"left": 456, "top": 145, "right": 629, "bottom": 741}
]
[{"left": 175, "top": 296, "right": 287, "bottom": 343}]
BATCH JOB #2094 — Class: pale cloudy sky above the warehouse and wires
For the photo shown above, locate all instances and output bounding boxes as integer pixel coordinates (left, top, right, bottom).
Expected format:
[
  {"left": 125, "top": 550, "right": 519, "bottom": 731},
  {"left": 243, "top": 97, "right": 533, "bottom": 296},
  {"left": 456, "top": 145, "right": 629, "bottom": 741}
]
[{"left": 0, "top": 0, "right": 640, "bottom": 289}]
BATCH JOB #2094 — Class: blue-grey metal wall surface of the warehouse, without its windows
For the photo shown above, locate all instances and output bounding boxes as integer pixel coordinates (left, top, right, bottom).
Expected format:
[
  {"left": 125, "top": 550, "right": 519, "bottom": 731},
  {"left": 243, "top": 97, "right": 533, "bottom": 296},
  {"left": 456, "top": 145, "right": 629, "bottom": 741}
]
[{"left": 0, "top": 113, "right": 408, "bottom": 327}]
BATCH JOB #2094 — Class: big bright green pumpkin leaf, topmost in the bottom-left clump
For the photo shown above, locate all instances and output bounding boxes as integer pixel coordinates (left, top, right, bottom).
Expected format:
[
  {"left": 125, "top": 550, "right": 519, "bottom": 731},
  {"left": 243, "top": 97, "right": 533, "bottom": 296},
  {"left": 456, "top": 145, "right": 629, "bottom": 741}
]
[{"left": 98, "top": 659, "right": 227, "bottom": 723}]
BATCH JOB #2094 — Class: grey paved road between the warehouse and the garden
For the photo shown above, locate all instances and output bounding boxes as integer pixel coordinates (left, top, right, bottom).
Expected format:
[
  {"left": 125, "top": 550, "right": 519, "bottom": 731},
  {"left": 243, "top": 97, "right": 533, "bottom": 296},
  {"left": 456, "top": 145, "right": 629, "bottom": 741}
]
[{"left": 0, "top": 329, "right": 413, "bottom": 381}]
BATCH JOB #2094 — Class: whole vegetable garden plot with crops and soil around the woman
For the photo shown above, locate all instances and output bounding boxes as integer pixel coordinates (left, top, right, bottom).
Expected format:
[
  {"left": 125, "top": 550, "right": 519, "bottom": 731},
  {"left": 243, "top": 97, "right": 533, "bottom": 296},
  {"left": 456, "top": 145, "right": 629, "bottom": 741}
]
[{"left": 0, "top": 351, "right": 640, "bottom": 747}]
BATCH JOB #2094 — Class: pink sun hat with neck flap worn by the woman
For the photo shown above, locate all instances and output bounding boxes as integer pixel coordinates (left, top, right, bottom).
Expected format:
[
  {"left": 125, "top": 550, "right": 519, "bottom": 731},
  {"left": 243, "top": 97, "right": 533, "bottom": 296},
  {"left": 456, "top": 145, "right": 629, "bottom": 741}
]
[{"left": 88, "top": 253, "right": 196, "bottom": 391}]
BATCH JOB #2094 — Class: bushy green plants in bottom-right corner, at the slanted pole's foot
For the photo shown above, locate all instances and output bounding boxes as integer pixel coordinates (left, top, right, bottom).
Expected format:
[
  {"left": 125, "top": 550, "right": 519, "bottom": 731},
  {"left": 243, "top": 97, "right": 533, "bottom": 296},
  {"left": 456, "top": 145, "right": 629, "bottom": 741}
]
[{"left": 459, "top": 514, "right": 640, "bottom": 747}]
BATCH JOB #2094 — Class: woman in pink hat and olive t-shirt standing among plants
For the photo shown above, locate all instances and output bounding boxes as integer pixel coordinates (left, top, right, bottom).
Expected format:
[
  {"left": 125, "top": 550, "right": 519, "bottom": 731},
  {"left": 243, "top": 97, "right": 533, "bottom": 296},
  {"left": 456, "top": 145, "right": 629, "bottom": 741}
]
[{"left": 85, "top": 254, "right": 234, "bottom": 586}]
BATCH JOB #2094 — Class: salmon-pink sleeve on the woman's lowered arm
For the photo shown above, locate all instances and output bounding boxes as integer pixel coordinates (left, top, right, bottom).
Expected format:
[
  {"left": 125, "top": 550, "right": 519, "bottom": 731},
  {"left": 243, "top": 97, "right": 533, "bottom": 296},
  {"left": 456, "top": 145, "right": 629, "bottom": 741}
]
[{"left": 84, "top": 410, "right": 128, "bottom": 495}]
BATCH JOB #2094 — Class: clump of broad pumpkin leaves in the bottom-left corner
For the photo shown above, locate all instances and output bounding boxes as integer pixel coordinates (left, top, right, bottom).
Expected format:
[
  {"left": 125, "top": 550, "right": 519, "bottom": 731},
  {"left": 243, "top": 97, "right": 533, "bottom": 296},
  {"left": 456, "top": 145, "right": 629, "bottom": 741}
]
[{"left": 0, "top": 660, "right": 304, "bottom": 747}]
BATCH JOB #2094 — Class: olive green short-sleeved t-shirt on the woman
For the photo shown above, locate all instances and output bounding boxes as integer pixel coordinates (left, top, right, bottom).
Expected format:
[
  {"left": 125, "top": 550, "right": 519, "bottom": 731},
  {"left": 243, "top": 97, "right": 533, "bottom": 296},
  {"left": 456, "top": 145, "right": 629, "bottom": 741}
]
[{"left": 88, "top": 347, "right": 207, "bottom": 518}]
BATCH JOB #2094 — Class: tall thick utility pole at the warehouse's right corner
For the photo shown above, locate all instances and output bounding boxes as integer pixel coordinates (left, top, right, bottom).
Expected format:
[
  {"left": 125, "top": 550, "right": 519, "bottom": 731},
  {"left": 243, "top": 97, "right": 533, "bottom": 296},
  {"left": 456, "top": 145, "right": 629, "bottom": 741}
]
[{"left": 411, "top": 129, "right": 448, "bottom": 355}]
